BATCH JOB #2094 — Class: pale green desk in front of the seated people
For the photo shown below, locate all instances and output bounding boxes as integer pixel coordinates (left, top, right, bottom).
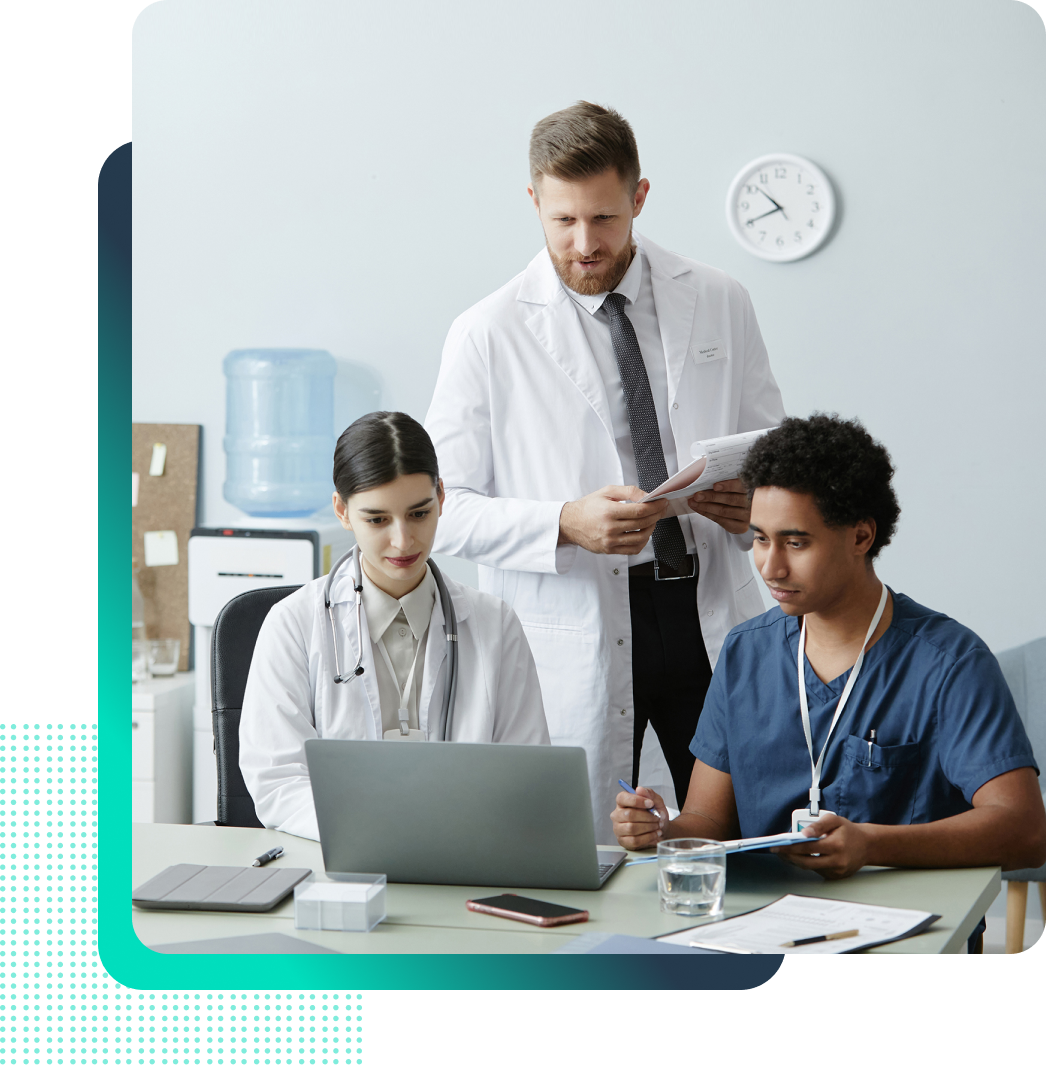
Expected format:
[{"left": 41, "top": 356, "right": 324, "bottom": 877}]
[{"left": 135, "top": 824, "right": 1001, "bottom": 954}]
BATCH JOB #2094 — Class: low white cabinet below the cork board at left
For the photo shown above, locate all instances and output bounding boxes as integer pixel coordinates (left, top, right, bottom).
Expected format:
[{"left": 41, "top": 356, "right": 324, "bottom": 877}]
[{"left": 131, "top": 673, "right": 196, "bottom": 824}]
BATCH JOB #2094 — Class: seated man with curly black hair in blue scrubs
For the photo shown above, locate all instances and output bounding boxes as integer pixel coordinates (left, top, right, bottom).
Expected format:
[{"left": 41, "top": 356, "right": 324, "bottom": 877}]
[{"left": 611, "top": 415, "right": 1046, "bottom": 879}]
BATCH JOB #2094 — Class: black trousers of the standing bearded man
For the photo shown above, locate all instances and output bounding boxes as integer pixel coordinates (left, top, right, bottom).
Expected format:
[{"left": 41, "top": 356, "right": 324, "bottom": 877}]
[{"left": 628, "top": 574, "right": 712, "bottom": 808}]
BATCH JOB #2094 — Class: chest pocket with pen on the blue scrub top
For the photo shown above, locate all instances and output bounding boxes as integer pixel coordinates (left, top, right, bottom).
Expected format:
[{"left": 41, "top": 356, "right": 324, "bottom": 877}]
[{"left": 838, "top": 736, "right": 919, "bottom": 824}]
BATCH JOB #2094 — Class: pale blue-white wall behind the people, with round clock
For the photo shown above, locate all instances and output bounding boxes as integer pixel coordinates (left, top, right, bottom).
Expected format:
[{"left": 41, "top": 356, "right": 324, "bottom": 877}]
[{"left": 132, "top": 0, "right": 1046, "bottom": 650}]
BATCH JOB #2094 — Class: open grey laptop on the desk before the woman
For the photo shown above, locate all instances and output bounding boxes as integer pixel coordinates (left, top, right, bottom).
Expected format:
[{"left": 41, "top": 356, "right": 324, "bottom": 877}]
[{"left": 305, "top": 739, "right": 625, "bottom": 890}]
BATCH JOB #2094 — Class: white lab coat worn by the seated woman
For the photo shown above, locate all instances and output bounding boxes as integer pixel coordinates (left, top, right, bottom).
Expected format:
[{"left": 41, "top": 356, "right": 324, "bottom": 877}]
[{"left": 240, "top": 564, "right": 549, "bottom": 839}]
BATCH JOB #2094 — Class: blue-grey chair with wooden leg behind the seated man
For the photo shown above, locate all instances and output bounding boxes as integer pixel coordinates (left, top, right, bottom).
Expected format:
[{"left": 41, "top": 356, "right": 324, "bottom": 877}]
[{"left": 996, "top": 636, "right": 1046, "bottom": 954}]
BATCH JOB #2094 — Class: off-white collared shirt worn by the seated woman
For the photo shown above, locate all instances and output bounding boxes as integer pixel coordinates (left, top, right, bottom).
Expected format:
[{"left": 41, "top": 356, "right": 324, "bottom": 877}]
[{"left": 361, "top": 566, "right": 436, "bottom": 732}]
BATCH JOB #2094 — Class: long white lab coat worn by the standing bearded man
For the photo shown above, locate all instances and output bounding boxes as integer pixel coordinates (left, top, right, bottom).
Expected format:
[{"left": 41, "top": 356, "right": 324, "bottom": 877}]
[{"left": 425, "top": 231, "right": 784, "bottom": 842}]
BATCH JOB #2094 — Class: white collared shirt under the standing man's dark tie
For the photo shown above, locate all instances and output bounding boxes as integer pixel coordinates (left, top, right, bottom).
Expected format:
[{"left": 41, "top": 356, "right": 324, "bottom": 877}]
[{"left": 560, "top": 243, "right": 694, "bottom": 566}]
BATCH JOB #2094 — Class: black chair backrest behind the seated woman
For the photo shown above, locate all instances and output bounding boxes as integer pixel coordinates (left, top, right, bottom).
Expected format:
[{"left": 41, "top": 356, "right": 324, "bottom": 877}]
[{"left": 211, "top": 585, "right": 301, "bottom": 829}]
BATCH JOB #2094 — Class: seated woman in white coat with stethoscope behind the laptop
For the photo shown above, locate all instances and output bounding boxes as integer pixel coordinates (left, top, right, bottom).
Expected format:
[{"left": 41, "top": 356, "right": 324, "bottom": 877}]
[{"left": 240, "top": 411, "right": 549, "bottom": 839}]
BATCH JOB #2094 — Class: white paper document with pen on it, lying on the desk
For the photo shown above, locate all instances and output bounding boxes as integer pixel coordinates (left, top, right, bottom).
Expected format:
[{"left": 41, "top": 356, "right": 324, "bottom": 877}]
[{"left": 657, "top": 895, "right": 941, "bottom": 954}]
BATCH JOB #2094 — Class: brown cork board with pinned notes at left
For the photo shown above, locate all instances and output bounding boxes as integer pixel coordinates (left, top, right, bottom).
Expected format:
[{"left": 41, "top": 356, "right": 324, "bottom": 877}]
[{"left": 131, "top": 423, "right": 200, "bottom": 670}]
